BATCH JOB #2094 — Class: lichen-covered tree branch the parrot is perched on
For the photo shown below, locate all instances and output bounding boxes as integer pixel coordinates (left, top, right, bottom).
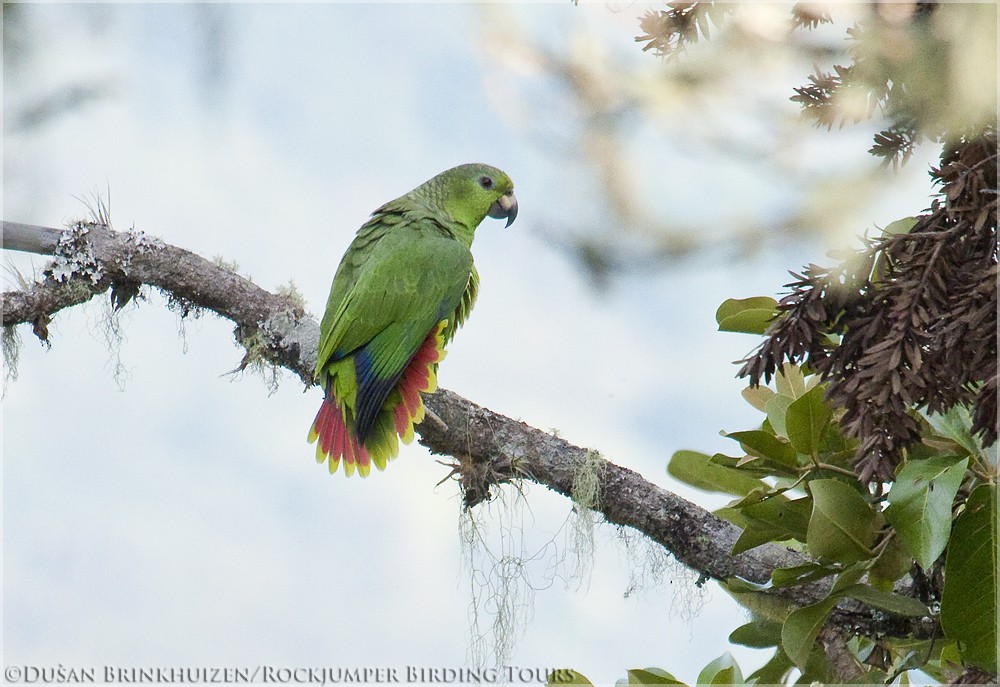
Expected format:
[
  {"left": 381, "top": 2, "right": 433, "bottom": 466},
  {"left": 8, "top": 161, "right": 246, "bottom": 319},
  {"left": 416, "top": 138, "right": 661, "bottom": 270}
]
[{"left": 2, "top": 222, "right": 939, "bottom": 637}]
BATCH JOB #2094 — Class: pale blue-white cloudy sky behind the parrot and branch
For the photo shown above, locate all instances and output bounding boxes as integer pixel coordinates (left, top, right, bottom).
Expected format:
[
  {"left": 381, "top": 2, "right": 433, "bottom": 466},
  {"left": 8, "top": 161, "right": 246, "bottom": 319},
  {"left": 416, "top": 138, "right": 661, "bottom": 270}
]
[{"left": 3, "top": 2, "right": 933, "bottom": 682}]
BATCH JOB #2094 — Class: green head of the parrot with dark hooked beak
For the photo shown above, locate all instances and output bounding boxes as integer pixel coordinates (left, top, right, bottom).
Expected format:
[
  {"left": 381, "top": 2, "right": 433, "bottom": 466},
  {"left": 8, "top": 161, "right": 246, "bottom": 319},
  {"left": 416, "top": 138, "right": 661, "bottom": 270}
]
[{"left": 413, "top": 164, "right": 517, "bottom": 230}]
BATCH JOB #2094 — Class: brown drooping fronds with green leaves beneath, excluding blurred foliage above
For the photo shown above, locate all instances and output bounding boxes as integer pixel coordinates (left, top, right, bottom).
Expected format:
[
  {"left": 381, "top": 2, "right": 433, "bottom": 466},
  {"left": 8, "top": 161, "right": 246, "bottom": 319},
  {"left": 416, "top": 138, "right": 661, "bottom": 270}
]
[{"left": 720, "top": 187, "right": 997, "bottom": 682}]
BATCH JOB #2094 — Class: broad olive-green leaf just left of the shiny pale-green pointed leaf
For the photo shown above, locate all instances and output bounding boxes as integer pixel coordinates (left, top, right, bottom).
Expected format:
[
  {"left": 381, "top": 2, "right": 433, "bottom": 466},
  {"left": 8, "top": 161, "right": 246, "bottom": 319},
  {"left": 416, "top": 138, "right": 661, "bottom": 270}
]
[{"left": 808, "top": 479, "right": 879, "bottom": 564}]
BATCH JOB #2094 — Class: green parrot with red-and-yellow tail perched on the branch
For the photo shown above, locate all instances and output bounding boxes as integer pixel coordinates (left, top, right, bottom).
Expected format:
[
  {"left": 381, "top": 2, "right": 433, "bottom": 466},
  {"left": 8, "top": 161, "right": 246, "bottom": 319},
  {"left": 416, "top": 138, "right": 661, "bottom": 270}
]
[{"left": 309, "top": 164, "right": 517, "bottom": 477}]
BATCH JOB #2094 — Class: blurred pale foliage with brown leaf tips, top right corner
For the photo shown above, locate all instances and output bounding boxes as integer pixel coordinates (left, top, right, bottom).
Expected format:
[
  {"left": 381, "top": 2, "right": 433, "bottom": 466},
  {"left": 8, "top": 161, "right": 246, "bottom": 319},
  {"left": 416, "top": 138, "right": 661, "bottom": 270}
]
[{"left": 636, "top": 2, "right": 996, "bottom": 166}]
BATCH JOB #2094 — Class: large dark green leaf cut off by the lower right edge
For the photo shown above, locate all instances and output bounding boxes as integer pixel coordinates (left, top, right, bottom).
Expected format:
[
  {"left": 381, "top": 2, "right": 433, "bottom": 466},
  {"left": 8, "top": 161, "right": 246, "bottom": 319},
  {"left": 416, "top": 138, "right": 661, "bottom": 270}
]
[{"left": 941, "top": 484, "right": 997, "bottom": 673}]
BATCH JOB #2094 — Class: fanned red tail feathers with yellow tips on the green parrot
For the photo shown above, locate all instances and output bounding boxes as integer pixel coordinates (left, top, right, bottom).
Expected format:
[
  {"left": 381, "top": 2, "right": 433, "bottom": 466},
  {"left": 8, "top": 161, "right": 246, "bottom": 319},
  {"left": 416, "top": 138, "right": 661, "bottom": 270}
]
[{"left": 309, "top": 320, "right": 448, "bottom": 477}]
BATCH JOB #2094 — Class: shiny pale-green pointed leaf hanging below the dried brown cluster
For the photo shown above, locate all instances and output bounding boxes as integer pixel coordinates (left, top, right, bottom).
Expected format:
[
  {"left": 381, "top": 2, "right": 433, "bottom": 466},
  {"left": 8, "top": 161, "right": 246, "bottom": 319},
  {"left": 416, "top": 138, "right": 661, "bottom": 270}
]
[{"left": 885, "top": 456, "right": 969, "bottom": 570}]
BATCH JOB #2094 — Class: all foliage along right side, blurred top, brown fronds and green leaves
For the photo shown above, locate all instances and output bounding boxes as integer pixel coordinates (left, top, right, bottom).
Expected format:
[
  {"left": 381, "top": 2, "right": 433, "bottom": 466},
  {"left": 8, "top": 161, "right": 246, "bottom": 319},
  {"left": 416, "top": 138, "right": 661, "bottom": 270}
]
[{"left": 560, "top": 2, "right": 998, "bottom": 685}]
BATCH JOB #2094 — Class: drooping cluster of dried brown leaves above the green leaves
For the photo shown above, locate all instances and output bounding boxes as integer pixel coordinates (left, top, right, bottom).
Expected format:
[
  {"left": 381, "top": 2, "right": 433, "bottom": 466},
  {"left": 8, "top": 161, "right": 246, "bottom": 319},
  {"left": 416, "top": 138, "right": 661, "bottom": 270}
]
[{"left": 740, "top": 129, "right": 997, "bottom": 482}]
